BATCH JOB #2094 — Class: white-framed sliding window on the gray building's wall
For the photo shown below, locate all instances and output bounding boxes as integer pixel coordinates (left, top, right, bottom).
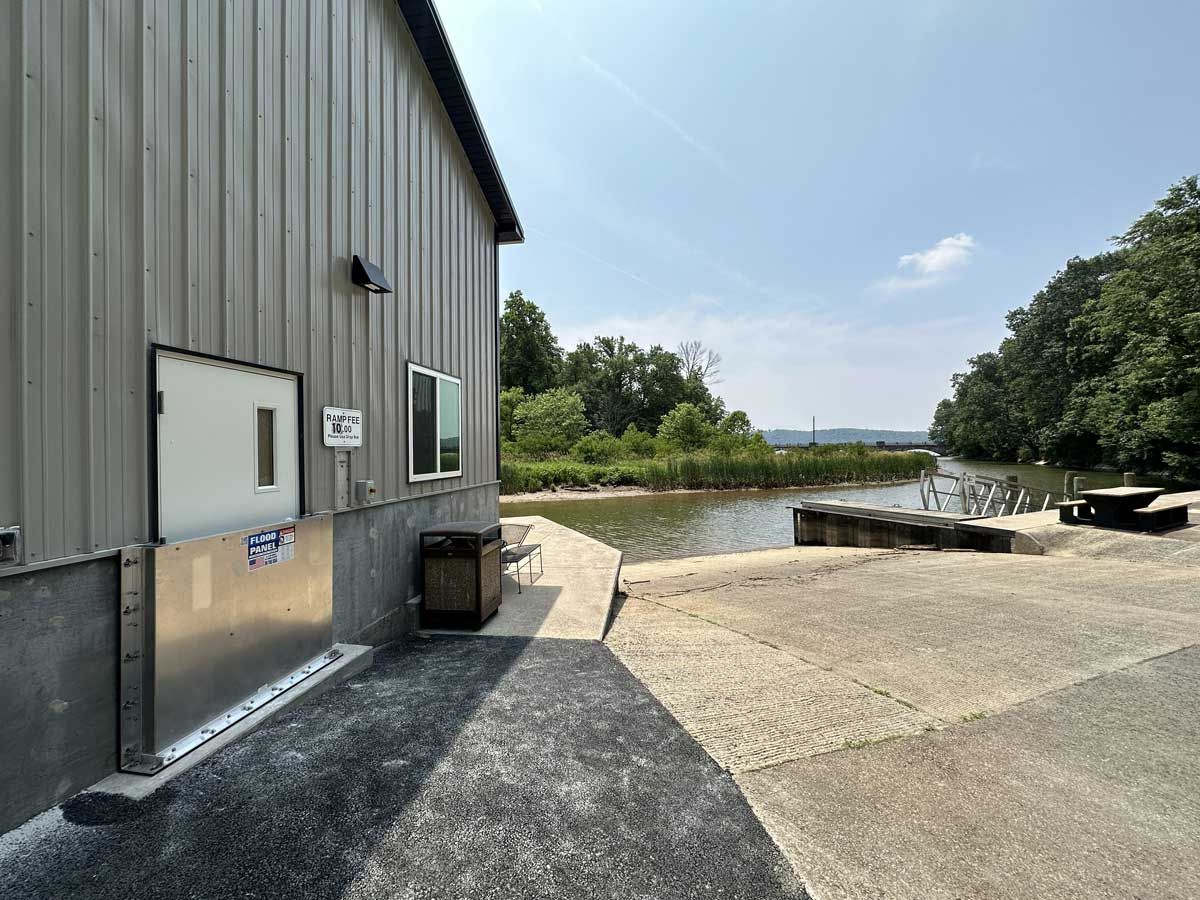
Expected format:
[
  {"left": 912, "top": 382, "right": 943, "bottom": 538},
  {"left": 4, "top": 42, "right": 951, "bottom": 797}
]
[{"left": 408, "top": 362, "right": 462, "bottom": 481}]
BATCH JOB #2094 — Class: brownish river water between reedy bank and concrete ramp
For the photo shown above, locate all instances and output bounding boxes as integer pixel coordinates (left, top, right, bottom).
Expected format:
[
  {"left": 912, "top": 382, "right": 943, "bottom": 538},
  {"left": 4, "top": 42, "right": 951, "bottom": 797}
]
[{"left": 500, "top": 458, "right": 1171, "bottom": 562}]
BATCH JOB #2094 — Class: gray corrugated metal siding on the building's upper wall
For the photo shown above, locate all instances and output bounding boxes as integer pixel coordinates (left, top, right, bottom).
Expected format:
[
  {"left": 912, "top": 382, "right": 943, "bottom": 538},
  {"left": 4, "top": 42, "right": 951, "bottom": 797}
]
[{"left": 7, "top": 0, "right": 497, "bottom": 563}]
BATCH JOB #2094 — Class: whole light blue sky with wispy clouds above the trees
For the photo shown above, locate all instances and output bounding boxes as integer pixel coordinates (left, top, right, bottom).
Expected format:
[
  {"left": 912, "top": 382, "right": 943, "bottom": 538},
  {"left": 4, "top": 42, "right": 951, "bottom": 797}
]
[{"left": 439, "top": 0, "right": 1200, "bottom": 428}]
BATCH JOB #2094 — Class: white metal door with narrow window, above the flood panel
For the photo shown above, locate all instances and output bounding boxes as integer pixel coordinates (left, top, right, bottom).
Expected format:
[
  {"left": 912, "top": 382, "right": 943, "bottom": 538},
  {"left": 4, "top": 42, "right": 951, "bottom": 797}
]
[{"left": 157, "top": 352, "right": 300, "bottom": 541}]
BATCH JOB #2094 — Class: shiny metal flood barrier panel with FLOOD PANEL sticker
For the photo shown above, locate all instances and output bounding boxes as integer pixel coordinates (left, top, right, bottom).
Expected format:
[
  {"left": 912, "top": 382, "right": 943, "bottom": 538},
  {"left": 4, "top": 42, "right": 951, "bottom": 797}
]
[{"left": 120, "top": 516, "right": 341, "bottom": 774}]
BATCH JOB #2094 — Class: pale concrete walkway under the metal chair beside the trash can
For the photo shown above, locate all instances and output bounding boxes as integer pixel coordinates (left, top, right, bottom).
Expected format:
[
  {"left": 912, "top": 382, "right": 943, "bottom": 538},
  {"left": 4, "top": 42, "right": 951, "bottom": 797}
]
[{"left": 430, "top": 516, "right": 622, "bottom": 641}]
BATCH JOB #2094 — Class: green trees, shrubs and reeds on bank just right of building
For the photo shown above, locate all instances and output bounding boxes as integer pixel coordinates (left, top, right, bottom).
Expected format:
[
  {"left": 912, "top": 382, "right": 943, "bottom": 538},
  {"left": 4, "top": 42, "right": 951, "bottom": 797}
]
[{"left": 500, "top": 290, "right": 930, "bottom": 494}]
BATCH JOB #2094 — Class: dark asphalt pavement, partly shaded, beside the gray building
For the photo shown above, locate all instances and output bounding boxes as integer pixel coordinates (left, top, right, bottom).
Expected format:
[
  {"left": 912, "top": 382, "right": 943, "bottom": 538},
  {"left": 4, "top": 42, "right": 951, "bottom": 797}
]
[{"left": 0, "top": 637, "right": 805, "bottom": 900}]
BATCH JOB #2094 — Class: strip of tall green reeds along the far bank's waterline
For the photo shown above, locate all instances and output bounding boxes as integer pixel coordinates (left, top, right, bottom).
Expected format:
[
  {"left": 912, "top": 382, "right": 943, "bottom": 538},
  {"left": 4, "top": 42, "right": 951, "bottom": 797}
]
[{"left": 500, "top": 451, "right": 930, "bottom": 493}]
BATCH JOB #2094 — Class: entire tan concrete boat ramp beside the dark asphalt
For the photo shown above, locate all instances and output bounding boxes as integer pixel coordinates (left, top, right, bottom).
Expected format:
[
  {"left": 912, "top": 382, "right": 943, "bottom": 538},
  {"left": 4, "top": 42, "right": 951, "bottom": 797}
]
[{"left": 607, "top": 547, "right": 1200, "bottom": 900}]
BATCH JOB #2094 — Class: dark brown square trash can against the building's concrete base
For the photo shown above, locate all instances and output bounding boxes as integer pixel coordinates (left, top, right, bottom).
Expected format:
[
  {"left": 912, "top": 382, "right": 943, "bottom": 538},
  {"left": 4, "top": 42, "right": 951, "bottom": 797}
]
[{"left": 421, "top": 522, "right": 504, "bottom": 630}]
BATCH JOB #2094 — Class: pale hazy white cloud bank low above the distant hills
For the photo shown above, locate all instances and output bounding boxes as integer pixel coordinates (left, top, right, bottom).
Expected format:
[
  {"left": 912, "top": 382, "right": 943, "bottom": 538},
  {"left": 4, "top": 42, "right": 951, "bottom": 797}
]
[{"left": 557, "top": 295, "right": 994, "bottom": 428}]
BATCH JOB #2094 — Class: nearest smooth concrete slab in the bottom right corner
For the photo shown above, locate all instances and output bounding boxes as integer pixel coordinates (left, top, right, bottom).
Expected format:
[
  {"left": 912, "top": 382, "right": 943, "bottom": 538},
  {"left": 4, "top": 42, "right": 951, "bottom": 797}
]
[{"left": 738, "top": 648, "right": 1200, "bottom": 900}]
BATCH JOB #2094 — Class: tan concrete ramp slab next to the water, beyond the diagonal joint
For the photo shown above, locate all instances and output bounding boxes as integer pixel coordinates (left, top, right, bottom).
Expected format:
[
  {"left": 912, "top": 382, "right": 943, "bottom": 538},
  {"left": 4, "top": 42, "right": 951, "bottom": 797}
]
[{"left": 610, "top": 547, "right": 1200, "bottom": 722}]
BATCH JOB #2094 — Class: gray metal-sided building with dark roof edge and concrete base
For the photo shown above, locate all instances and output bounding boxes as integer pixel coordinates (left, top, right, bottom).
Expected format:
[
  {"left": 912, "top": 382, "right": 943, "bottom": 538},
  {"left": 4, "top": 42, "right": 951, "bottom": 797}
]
[{"left": 0, "top": 0, "right": 522, "bottom": 830}]
